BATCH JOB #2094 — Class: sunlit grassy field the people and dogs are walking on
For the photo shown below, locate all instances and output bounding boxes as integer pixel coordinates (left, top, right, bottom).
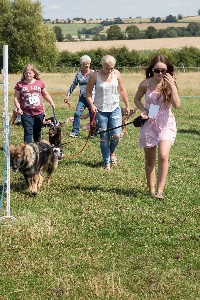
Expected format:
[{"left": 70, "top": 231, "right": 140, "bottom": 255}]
[{"left": 0, "top": 73, "right": 200, "bottom": 300}]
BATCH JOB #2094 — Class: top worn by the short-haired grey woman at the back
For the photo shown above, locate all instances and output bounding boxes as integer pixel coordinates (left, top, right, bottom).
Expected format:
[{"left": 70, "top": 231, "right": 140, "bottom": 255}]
[{"left": 66, "top": 70, "right": 94, "bottom": 97}]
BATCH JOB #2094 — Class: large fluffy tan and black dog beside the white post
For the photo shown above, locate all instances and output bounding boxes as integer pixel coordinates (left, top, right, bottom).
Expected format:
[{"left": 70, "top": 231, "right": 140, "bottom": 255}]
[{"left": 10, "top": 141, "right": 58, "bottom": 195}]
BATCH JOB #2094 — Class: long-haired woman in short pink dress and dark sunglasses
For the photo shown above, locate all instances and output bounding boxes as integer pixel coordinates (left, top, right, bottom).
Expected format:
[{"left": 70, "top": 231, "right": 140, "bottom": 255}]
[{"left": 134, "top": 55, "right": 180, "bottom": 199}]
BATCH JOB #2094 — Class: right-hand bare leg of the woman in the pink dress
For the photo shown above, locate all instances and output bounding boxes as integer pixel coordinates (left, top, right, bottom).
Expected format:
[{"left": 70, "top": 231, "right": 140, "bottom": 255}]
[{"left": 157, "top": 140, "right": 172, "bottom": 194}]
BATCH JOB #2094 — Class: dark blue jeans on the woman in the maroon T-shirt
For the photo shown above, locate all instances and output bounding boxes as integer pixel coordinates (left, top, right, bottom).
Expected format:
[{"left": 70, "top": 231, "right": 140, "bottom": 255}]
[{"left": 21, "top": 114, "right": 44, "bottom": 144}]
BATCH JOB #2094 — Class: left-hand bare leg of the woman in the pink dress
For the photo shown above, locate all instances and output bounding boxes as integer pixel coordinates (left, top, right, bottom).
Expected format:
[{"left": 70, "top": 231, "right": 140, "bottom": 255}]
[{"left": 144, "top": 146, "right": 156, "bottom": 193}]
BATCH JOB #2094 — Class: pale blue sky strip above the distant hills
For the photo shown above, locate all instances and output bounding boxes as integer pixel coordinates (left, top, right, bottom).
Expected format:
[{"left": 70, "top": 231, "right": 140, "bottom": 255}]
[{"left": 40, "top": 0, "right": 200, "bottom": 20}]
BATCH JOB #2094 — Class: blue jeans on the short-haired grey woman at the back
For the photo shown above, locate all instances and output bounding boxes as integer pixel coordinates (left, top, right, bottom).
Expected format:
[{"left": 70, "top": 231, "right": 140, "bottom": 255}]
[{"left": 72, "top": 95, "right": 92, "bottom": 135}]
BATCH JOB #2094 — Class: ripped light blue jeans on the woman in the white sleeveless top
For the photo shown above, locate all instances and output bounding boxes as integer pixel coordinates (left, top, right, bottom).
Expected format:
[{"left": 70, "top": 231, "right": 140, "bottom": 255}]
[{"left": 97, "top": 107, "right": 122, "bottom": 165}]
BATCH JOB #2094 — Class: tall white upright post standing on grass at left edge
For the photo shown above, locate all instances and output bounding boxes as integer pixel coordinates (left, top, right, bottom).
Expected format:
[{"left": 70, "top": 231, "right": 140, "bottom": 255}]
[{"left": 0, "top": 45, "right": 15, "bottom": 221}]
